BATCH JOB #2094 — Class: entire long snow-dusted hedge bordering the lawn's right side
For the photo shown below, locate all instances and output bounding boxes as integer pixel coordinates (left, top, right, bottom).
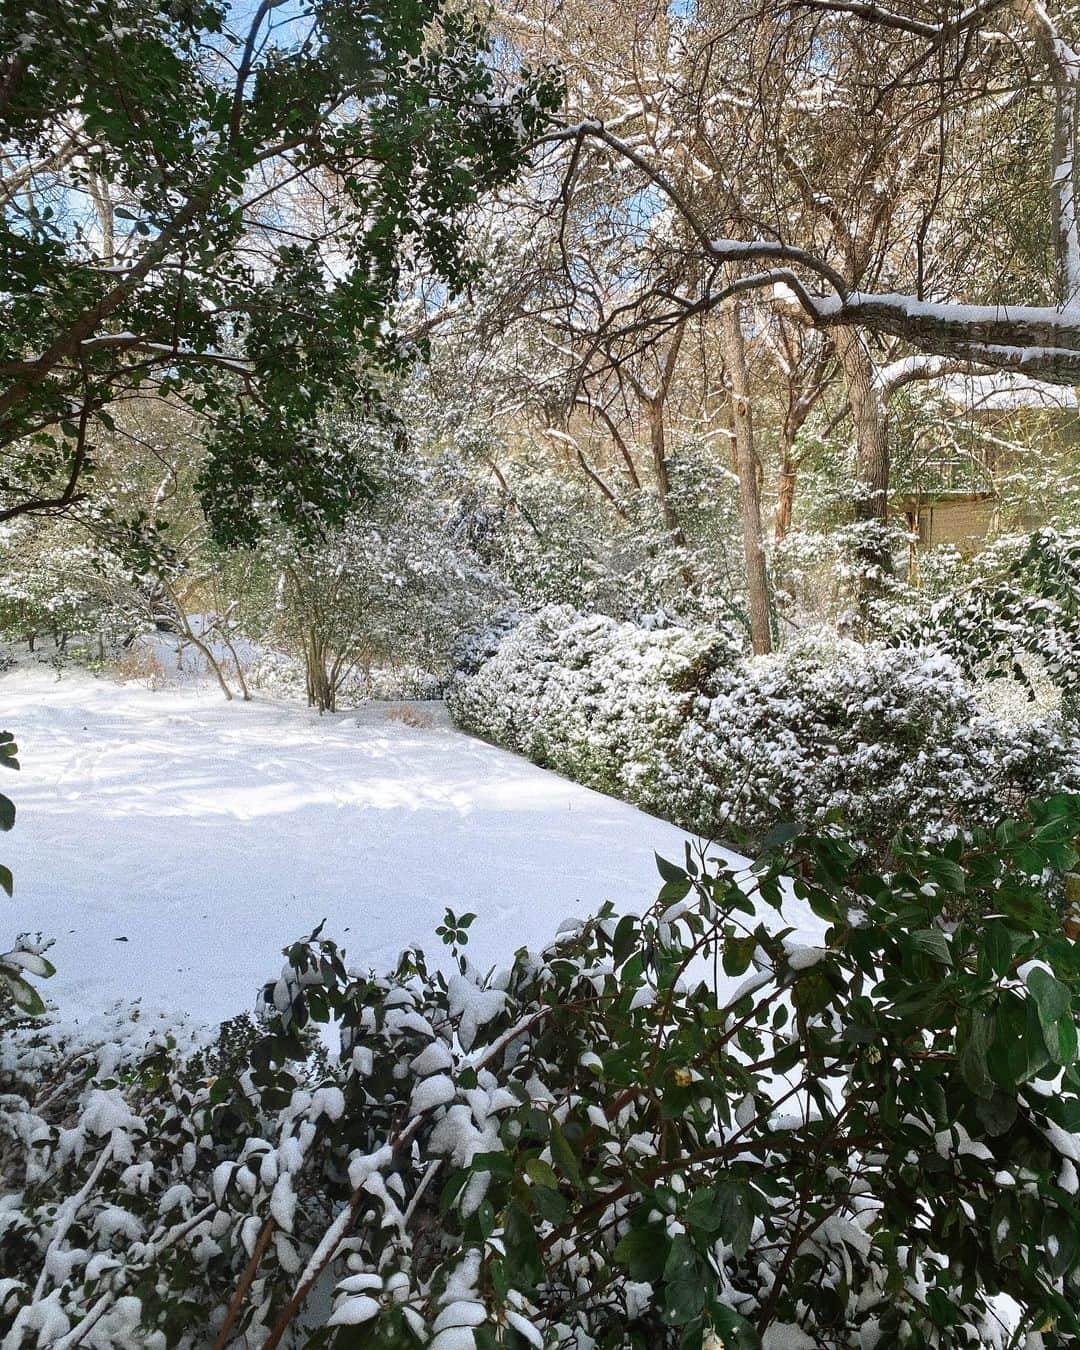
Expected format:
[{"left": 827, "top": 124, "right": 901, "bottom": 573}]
[{"left": 447, "top": 609, "right": 1080, "bottom": 851}]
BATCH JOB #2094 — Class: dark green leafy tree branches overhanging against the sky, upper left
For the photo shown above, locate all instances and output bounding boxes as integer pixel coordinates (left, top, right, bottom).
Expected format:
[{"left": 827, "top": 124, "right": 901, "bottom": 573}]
[{"left": 0, "top": 0, "right": 556, "bottom": 543}]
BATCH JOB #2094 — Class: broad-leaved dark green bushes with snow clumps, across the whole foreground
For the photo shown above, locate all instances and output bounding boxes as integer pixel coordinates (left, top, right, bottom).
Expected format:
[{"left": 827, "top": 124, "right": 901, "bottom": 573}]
[{"left": 0, "top": 799, "right": 1080, "bottom": 1350}]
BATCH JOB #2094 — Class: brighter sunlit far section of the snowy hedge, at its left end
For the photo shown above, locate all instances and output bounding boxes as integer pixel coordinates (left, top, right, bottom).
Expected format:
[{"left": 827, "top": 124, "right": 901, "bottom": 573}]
[{"left": 447, "top": 605, "right": 738, "bottom": 809}]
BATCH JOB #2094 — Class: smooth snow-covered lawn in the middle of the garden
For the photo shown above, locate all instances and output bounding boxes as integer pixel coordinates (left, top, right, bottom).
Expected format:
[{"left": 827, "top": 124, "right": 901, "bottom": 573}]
[{"left": 0, "top": 670, "right": 821, "bottom": 1021}]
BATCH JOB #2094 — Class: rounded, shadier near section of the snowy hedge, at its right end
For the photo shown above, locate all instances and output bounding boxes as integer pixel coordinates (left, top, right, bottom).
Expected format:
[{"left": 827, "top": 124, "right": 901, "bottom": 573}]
[{"left": 671, "top": 636, "right": 1080, "bottom": 845}]
